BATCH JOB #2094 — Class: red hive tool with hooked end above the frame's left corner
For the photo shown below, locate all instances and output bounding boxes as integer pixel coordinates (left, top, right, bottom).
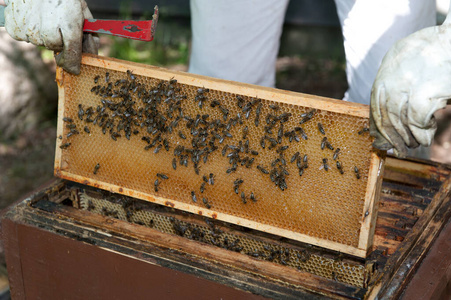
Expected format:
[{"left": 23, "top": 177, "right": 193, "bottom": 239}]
[{"left": 83, "top": 6, "right": 158, "bottom": 42}]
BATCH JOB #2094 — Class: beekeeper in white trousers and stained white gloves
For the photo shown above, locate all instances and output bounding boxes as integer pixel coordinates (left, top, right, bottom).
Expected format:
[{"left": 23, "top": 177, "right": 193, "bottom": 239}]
[{"left": 0, "top": 0, "right": 451, "bottom": 156}]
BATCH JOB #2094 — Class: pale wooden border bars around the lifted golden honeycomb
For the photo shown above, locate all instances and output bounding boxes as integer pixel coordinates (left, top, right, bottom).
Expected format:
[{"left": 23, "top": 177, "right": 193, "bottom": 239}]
[{"left": 55, "top": 55, "right": 384, "bottom": 257}]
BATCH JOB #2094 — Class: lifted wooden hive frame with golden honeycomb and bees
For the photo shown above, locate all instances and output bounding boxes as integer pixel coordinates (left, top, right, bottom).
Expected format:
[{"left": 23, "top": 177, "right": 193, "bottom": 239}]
[{"left": 55, "top": 55, "right": 383, "bottom": 257}]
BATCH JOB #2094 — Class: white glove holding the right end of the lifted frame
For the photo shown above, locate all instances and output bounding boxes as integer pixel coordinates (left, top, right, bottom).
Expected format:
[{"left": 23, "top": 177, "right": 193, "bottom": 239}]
[{"left": 370, "top": 23, "right": 451, "bottom": 157}]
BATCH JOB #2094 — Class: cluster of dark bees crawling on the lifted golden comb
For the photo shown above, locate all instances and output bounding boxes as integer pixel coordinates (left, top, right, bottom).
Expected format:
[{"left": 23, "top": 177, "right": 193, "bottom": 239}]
[{"left": 60, "top": 70, "right": 368, "bottom": 208}]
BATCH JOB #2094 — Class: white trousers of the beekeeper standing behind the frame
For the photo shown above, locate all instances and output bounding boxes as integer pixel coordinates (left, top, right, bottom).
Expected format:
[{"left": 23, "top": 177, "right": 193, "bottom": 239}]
[{"left": 189, "top": 0, "right": 436, "bottom": 104}]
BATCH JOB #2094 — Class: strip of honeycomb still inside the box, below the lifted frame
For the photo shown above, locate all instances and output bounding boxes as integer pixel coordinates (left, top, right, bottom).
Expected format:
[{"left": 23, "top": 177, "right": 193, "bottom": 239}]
[{"left": 79, "top": 193, "right": 365, "bottom": 287}]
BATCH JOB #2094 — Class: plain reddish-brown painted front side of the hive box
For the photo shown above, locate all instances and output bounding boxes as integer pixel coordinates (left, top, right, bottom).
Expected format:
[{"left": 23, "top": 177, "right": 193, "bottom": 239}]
[{"left": 5, "top": 220, "right": 264, "bottom": 299}]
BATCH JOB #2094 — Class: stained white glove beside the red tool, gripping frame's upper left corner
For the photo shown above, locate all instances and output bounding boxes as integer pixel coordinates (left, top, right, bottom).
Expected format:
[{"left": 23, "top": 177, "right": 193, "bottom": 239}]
[{"left": 5, "top": 0, "right": 98, "bottom": 74}]
